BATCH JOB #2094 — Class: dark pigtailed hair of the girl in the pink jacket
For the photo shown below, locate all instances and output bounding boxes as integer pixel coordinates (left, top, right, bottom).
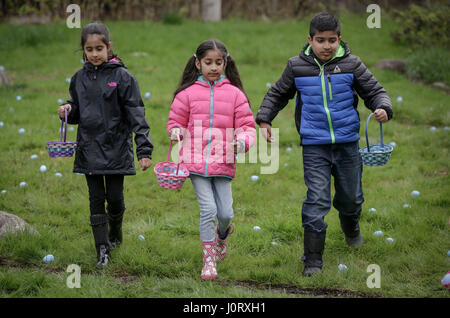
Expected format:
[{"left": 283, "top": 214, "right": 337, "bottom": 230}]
[{"left": 173, "top": 40, "right": 248, "bottom": 99}]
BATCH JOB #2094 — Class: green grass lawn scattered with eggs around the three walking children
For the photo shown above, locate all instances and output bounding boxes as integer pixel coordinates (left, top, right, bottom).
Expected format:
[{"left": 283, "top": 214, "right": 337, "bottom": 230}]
[{"left": 0, "top": 15, "right": 450, "bottom": 298}]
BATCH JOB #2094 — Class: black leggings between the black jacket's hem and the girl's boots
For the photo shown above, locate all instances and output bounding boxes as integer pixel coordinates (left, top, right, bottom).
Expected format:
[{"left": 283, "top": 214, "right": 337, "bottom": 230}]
[{"left": 86, "top": 175, "right": 125, "bottom": 216}]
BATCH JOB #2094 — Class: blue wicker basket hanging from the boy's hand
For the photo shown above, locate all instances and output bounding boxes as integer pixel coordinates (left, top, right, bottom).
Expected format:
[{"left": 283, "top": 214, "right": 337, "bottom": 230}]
[{"left": 359, "top": 113, "right": 394, "bottom": 166}]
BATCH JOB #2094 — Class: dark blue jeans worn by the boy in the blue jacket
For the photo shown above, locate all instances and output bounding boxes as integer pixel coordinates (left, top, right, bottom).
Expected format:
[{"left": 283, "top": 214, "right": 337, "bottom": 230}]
[{"left": 302, "top": 141, "right": 364, "bottom": 232}]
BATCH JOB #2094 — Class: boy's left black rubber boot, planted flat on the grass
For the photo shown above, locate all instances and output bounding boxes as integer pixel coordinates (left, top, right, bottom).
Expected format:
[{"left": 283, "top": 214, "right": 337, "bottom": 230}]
[{"left": 302, "top": 229, "right": 326, "bottom": 276}]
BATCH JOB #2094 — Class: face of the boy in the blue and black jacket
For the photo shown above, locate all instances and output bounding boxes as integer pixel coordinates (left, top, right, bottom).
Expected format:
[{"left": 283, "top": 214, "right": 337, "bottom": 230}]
[{"left": 308, "top": 31, "right": 342, "bottom": 62}]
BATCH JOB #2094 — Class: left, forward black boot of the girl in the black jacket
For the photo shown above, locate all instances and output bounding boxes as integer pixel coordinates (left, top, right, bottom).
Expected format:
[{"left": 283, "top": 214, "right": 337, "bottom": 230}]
[{"left": 91, "top": 214, "right": 110, "bottom": 268}]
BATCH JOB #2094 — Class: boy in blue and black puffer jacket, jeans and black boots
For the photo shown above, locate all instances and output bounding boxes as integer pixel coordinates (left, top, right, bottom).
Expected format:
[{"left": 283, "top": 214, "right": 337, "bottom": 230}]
[{"left": 256, "top": 12, "right": 393, "bottom": 276}]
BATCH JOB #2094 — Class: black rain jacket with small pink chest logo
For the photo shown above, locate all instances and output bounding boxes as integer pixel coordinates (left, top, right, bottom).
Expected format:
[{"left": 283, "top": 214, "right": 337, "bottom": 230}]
[{"left": 67, "top": 59, "right": 153, "bottom": 175}]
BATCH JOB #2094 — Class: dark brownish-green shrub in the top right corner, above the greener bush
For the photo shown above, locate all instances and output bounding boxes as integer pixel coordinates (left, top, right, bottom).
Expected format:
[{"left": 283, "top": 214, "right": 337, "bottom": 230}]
[{"left": 392, "top": 2, "right": 450, "bottom": 48}]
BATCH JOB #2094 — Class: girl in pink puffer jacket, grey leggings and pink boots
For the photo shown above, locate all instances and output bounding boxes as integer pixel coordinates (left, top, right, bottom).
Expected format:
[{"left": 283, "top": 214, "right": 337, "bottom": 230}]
[{"left": 167, "top": 40, "right": 256, "bottom": 279}]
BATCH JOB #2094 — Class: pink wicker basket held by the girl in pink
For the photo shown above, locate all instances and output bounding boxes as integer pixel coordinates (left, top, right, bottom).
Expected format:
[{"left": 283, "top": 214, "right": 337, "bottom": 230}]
[{"left": 153, "top": 137, "right": 189, "bottom": 189}]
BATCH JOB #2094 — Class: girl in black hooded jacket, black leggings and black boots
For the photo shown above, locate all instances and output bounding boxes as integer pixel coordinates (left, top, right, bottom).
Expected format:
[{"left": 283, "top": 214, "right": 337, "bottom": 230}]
[{"left": 58, "top": 23, "right": 153, "bottom": 267}]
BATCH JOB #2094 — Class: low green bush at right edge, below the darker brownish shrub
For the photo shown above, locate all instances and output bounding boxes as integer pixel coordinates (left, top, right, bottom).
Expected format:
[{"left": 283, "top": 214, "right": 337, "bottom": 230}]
[{"left": 405, "top": 47, "right": 450, "bottom": 85}]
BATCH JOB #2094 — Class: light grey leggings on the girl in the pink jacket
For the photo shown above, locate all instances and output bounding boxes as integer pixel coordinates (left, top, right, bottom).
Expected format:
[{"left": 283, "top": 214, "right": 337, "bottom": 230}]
[{"left": 190, "top": 174, "right": 234, "bottom": 242}]
